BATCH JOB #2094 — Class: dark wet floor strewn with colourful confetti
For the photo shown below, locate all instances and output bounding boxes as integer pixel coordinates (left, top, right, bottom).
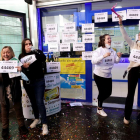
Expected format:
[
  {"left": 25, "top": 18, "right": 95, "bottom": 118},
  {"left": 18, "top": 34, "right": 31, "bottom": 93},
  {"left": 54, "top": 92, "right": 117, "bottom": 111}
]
[{"left": 0, "top": 104, "right": 140, "bottom": 140}]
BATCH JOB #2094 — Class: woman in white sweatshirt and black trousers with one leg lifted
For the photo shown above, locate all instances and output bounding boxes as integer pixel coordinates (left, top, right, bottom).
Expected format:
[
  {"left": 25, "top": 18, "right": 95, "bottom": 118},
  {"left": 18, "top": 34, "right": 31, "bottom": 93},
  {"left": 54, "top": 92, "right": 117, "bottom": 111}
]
[{"left": 92, "top": 34, "right": 121, "bottom": 116}]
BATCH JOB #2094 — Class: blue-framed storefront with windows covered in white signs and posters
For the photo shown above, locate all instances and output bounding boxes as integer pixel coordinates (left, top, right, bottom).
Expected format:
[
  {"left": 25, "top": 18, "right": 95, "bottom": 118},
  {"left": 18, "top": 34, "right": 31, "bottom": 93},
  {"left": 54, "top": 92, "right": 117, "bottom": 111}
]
[{"left": 32, "top": 1, "right": 140, "bottom": 108}]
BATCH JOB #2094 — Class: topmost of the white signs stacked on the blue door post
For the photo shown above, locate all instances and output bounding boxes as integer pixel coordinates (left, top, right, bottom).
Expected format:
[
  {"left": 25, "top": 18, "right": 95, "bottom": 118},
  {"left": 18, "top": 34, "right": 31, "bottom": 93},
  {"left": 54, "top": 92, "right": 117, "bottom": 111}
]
[{"left": 82, "top": 23, "right": 94, "bottom": 33}]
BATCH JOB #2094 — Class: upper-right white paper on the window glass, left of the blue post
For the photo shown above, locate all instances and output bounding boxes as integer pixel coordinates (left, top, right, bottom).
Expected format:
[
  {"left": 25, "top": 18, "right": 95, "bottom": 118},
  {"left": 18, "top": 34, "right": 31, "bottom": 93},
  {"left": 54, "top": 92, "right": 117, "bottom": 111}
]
[{"left": 64, "top": 22, "right": 76, "bottom": 32}]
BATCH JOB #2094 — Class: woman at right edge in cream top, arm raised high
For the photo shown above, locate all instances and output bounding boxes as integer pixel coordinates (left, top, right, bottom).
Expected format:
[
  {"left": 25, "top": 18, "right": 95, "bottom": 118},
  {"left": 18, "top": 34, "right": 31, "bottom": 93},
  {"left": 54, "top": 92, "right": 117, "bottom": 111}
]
[{"left": 119, "top": 16, "right": 140, "bottom": 124}]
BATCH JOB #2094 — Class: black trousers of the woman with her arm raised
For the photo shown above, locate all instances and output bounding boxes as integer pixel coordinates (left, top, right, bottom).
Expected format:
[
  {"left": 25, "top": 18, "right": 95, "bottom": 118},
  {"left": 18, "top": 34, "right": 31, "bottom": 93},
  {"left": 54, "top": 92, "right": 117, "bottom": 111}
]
[{"left": 124, "top": 67, "right": 140, "bottom": 120}]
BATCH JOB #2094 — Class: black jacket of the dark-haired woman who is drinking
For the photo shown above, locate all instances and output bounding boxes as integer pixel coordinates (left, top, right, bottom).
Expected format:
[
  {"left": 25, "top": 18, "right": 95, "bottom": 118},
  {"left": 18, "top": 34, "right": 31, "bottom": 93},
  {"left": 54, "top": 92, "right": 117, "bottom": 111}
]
[{"left": 19, "top": 50, "right": 46, "bottom": 81}]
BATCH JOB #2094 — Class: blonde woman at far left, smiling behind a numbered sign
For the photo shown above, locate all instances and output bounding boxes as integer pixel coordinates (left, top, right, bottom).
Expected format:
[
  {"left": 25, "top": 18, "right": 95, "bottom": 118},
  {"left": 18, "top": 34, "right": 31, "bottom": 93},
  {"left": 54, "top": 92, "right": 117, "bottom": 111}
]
[{"left": 0, "top": 46, "right": 28, "bottom": 139}]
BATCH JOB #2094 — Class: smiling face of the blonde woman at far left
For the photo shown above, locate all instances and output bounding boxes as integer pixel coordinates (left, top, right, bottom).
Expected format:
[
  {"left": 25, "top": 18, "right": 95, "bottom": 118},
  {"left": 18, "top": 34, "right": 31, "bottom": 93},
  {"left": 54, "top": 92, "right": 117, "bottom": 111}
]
[{"left": 1, "top": 48, "right": 13, "bottom": 61}]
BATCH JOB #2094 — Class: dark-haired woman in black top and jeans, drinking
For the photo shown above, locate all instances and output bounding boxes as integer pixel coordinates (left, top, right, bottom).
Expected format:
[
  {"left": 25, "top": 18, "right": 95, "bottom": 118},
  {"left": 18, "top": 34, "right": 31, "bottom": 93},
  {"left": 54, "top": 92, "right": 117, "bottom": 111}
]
[{"left": 19, "top": 38, "right": 48, "bottom": 135}]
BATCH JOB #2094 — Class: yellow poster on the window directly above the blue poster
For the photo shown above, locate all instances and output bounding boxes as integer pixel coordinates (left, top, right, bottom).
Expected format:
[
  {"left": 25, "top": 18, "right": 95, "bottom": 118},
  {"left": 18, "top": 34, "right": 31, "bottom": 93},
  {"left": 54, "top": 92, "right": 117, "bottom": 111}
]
[{"left": 59, "top": 58, "right": 85, "bottom": 74}]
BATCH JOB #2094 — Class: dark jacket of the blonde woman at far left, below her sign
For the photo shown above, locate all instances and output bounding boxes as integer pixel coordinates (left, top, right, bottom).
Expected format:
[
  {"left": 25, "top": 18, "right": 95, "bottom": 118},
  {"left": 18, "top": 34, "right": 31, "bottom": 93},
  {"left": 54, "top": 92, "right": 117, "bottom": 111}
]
[{"left": 0, "top": 73, "right": 22, "bottom": 104}]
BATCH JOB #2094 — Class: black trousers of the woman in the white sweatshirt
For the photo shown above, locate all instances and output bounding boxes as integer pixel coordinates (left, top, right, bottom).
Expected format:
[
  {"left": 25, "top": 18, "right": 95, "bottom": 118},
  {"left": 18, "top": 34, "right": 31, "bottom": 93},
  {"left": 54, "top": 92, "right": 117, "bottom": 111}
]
[{"left": 94, "top": 74, "right": 112, "bottom": 107}]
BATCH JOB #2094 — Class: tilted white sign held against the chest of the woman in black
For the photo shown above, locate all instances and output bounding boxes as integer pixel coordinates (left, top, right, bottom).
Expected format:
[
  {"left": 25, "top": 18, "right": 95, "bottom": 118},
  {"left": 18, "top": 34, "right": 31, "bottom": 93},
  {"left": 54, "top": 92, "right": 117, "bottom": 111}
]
[{"left": 20, "top": 54, "right": 36, "bottom": 64}]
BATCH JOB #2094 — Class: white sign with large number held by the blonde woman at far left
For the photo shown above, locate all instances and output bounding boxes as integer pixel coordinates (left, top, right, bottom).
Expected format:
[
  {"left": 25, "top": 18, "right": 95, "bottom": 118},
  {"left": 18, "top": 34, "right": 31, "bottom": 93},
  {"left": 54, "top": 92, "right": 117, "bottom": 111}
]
[{"left": 0, "top": 60, "right": 18, "bottom": 73}]
